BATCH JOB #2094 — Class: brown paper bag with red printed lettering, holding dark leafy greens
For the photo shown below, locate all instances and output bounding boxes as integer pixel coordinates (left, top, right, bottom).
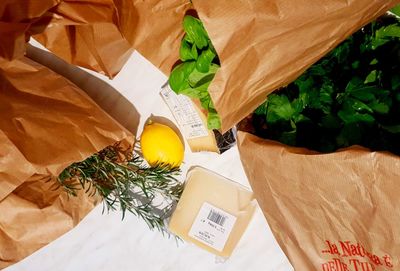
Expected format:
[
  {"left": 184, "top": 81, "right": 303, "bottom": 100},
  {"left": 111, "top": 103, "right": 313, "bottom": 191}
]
[{"left": 238, "top": 132, "right": 400, "bottom": 271}]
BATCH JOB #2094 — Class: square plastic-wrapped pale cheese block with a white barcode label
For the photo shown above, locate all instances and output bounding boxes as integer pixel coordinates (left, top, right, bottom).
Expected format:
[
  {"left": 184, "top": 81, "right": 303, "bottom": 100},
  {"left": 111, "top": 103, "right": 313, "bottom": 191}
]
[{"left": 169, "top": 167, "right": 257, "bottom": 257}]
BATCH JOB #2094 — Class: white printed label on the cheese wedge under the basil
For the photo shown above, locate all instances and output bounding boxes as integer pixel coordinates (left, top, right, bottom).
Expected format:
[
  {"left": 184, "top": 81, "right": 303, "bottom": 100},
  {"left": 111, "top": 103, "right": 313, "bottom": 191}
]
[{"left": 160, "top": 84, "right": 208, "bottom": 139}]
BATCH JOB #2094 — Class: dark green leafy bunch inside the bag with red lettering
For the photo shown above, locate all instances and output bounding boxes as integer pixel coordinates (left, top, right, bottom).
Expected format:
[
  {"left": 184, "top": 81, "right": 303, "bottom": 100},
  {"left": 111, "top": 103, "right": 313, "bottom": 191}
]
[{"left": 253, "top": 16, "right": 400, "bottom": 154}]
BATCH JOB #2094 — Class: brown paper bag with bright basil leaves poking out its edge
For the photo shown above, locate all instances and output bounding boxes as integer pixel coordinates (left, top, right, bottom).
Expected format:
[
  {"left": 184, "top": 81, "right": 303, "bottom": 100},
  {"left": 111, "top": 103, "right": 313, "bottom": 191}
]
[{"left": 193, "top": 0, "right": 400, "bottom": 131}]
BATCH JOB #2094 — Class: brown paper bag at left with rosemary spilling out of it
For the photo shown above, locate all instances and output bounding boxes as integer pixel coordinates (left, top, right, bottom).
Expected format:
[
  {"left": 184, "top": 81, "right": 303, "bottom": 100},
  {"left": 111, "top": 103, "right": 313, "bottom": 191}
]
[{"left": 0, "top": 55, "right": 132, "bottom": 269}]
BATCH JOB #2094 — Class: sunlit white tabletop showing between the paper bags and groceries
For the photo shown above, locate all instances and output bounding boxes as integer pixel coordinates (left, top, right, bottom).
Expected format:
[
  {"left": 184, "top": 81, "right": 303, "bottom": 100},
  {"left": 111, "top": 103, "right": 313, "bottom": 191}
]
[{"left": 5, "top": 43, "right": 293, "bottom": 271}]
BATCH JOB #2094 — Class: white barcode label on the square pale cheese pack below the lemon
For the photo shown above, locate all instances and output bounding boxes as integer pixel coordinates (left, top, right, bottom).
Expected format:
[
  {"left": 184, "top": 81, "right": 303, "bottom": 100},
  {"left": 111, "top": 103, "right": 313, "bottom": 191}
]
[{"left": 189, "top": 202, "right": 236, "bottom": 251}]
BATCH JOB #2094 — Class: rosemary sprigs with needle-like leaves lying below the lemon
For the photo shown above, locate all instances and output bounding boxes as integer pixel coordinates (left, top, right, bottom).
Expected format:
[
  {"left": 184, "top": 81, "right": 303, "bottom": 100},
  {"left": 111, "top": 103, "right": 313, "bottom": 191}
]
[{"left": 57, "top": 144, "right": 183, "bottom": 234}]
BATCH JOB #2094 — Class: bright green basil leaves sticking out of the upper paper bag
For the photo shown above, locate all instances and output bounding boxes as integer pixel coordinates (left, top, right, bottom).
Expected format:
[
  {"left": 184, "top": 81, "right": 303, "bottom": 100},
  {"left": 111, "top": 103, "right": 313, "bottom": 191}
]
[{"left": 169, "top": 15, "right": 221, "bottom": 129}]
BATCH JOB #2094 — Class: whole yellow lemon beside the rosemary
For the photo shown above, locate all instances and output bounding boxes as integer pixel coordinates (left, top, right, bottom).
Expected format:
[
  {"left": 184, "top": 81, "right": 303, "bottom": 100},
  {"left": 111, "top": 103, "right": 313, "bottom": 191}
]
[{"left": 140, "top": 121, "right": 184, "bottom": 167}]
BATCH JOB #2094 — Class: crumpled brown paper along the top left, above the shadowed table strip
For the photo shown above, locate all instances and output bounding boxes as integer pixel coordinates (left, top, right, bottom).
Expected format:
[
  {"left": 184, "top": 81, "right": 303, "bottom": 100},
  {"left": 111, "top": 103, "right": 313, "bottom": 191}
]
[{"left": 0, "top": 0, "right": 190, "bottom": 78}]
